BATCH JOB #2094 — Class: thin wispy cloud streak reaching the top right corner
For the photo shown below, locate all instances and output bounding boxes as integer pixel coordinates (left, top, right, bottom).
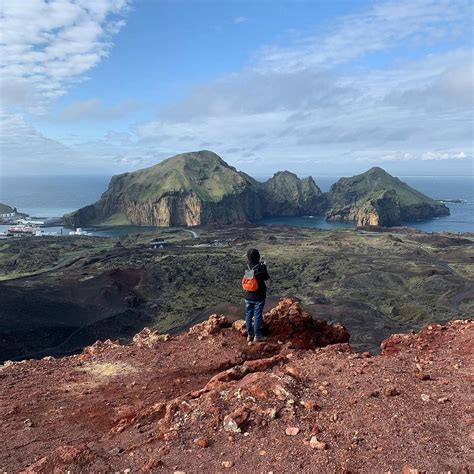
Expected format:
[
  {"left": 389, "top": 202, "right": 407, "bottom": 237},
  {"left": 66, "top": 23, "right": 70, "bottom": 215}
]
[{"left": 256, "top": 0, "right": 472, "bottom": 72}]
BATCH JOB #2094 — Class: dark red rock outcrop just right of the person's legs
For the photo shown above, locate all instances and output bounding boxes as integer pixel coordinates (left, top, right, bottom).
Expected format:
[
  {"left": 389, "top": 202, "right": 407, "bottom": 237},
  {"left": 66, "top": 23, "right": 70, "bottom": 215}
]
[{"left": 263, "top": 298, "right": 349, "bottom": 349}]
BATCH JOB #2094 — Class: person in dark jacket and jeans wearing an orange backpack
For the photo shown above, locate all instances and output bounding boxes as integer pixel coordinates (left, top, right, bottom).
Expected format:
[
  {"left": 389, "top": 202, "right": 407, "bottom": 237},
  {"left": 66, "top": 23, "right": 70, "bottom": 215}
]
[{"left": 242, "top": 249, "right": 270, "bottom": 342}]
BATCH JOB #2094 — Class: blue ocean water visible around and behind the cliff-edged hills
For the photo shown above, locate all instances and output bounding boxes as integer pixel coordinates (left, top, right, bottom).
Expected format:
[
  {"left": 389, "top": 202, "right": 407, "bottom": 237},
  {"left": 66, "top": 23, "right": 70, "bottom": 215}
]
[{"left": 0, "top": 176, "right": 474, "bottom": 235}]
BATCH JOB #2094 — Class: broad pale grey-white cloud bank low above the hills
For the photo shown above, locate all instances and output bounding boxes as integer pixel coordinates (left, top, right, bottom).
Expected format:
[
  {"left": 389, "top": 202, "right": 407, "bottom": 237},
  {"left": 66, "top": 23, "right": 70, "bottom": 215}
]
[{"left": 134, "top": 45, "right": 473, "bottom": 173}]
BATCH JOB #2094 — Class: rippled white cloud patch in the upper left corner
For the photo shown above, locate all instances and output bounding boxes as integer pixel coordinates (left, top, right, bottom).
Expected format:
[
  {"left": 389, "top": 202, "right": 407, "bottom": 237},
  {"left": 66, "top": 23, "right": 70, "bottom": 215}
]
[{"left": 0, "top": 0, "right": 128, "bottom": 112}]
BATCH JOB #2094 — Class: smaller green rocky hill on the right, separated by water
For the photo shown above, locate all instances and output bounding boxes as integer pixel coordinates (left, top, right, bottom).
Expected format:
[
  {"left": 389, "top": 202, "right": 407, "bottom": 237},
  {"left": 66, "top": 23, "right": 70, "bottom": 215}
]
[{"left": 326, "top": 167, "right": 449, "bottom": 226}]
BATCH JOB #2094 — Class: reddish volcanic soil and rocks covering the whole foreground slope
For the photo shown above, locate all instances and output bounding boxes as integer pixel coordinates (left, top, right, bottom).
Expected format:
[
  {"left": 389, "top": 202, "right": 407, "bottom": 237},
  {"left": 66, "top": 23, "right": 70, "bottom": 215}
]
[{"left": 0, "top": 300, "right": 474, "bottom": 473}]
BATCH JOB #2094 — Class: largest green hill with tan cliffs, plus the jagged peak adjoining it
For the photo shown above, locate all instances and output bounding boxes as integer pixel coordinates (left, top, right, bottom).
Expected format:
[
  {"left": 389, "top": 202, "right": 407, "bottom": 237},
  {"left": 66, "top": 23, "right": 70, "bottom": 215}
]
[{"left": 65, "top": 150, "right": 324, "bottom": 227}]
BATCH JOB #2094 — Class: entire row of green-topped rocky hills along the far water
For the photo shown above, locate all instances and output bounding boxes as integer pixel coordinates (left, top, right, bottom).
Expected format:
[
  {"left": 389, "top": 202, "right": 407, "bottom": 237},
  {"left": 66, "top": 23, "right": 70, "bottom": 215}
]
[{"left": 64, "top": 150, "right": 449, "bottom": 227}]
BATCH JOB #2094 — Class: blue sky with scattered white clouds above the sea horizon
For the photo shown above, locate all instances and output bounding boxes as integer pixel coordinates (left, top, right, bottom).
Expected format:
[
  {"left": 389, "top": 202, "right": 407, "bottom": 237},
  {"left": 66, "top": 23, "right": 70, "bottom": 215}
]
[{"left": 0, "top": 0, "right": 474, "bottom": 176}]
